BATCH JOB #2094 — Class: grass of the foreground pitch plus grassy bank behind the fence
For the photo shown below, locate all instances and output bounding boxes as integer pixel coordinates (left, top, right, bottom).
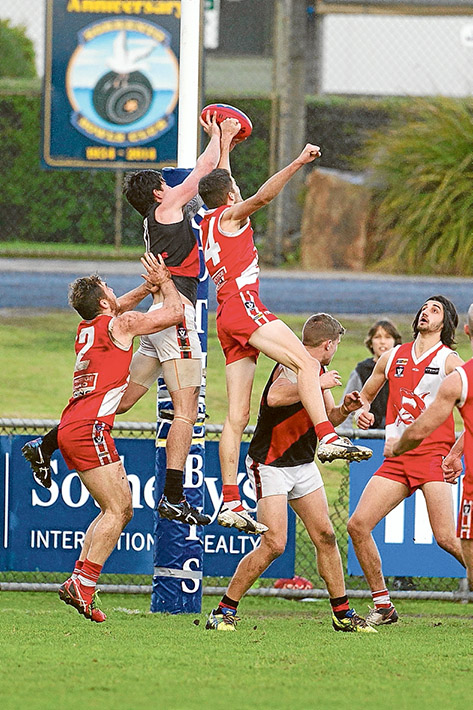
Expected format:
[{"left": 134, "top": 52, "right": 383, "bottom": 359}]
[{"left": 0, "top": 312, "right": 473, "bottom": 710}]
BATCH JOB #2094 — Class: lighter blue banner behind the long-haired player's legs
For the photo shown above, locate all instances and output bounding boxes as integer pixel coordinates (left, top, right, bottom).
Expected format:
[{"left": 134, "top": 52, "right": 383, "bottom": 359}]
[{"left": 348, "top": 439, "right": 465, "bottom": 577}]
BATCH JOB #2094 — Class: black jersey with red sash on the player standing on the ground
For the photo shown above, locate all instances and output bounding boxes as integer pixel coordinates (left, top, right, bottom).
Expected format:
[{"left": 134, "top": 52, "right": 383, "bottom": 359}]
[{"left": 248, "top": 365, "right": 317, "bottom": 467}]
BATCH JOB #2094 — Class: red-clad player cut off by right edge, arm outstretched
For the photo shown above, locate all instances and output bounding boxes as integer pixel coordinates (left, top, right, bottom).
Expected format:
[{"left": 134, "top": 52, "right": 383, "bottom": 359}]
[{"left": 385, "top": 304, "right": 473, "bottom": 589}]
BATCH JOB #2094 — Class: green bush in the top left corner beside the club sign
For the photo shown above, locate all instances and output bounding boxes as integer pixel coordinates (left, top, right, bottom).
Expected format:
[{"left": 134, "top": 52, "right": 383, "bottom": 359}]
[{"left": 0, "top": 20, "right": 36, "bottom": 78}]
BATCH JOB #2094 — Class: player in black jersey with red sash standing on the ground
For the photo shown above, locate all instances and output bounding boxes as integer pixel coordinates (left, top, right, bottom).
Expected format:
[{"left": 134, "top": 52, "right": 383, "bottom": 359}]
[{"left": 206, "top": 313, "right": 375, "bottom": 633}]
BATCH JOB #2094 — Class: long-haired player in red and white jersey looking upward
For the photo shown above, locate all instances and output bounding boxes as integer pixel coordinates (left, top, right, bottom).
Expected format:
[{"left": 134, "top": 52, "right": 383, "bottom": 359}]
[{"left": 348, "top": 296, "right": 463, "bottom": 625}]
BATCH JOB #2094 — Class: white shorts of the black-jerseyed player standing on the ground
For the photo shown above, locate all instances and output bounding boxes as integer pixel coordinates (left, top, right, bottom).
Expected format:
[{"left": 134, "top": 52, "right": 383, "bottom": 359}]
[{"left": 245, "top": 456, "right": 324, "bottom": 500}]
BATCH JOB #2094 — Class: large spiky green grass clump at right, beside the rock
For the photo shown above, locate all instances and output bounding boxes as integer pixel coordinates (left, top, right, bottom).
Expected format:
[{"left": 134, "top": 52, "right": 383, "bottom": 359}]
[{"left": 365, "top": 98, "right": 473, "bottom": 276}]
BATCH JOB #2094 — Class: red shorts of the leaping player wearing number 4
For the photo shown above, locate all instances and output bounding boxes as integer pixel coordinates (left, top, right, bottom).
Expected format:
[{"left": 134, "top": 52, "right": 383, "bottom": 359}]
[{"left": 217, "top": 291, "right": 278, "bottom": 365}]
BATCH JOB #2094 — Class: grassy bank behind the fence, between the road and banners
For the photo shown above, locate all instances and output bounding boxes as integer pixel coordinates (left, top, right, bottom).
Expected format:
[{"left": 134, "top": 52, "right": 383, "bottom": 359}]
[{"left": 0, "top": 310, "right": 471, "bottom": 428}]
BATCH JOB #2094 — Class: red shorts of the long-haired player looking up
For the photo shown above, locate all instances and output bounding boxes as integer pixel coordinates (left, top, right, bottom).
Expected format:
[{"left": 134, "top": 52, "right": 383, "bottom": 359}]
[{"left": 374, "top": 454, "right": 449, "bottom": 495}]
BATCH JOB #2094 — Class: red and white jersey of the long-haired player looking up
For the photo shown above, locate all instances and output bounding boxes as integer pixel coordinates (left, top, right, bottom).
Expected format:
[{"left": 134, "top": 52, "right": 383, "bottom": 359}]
[{"left": 385, "top": 342, "right": 455, "bottom": 456}]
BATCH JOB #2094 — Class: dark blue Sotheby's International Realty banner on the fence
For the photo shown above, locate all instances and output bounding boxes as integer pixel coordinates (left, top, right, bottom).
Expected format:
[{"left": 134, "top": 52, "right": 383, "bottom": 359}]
[{"left": 0, "top": 435, "right": 295, "bottom": 588}]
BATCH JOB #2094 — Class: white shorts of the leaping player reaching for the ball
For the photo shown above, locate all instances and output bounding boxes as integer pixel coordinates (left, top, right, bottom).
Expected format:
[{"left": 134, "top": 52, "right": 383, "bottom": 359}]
[{"left": 138, "top": 303, "right": 202, "bottom": 362}]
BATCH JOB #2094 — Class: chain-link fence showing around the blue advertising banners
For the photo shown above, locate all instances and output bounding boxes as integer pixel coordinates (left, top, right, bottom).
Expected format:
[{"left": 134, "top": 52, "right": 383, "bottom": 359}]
[{"left": 0, "top": 419, "right": 472, "bottom": 600}]
